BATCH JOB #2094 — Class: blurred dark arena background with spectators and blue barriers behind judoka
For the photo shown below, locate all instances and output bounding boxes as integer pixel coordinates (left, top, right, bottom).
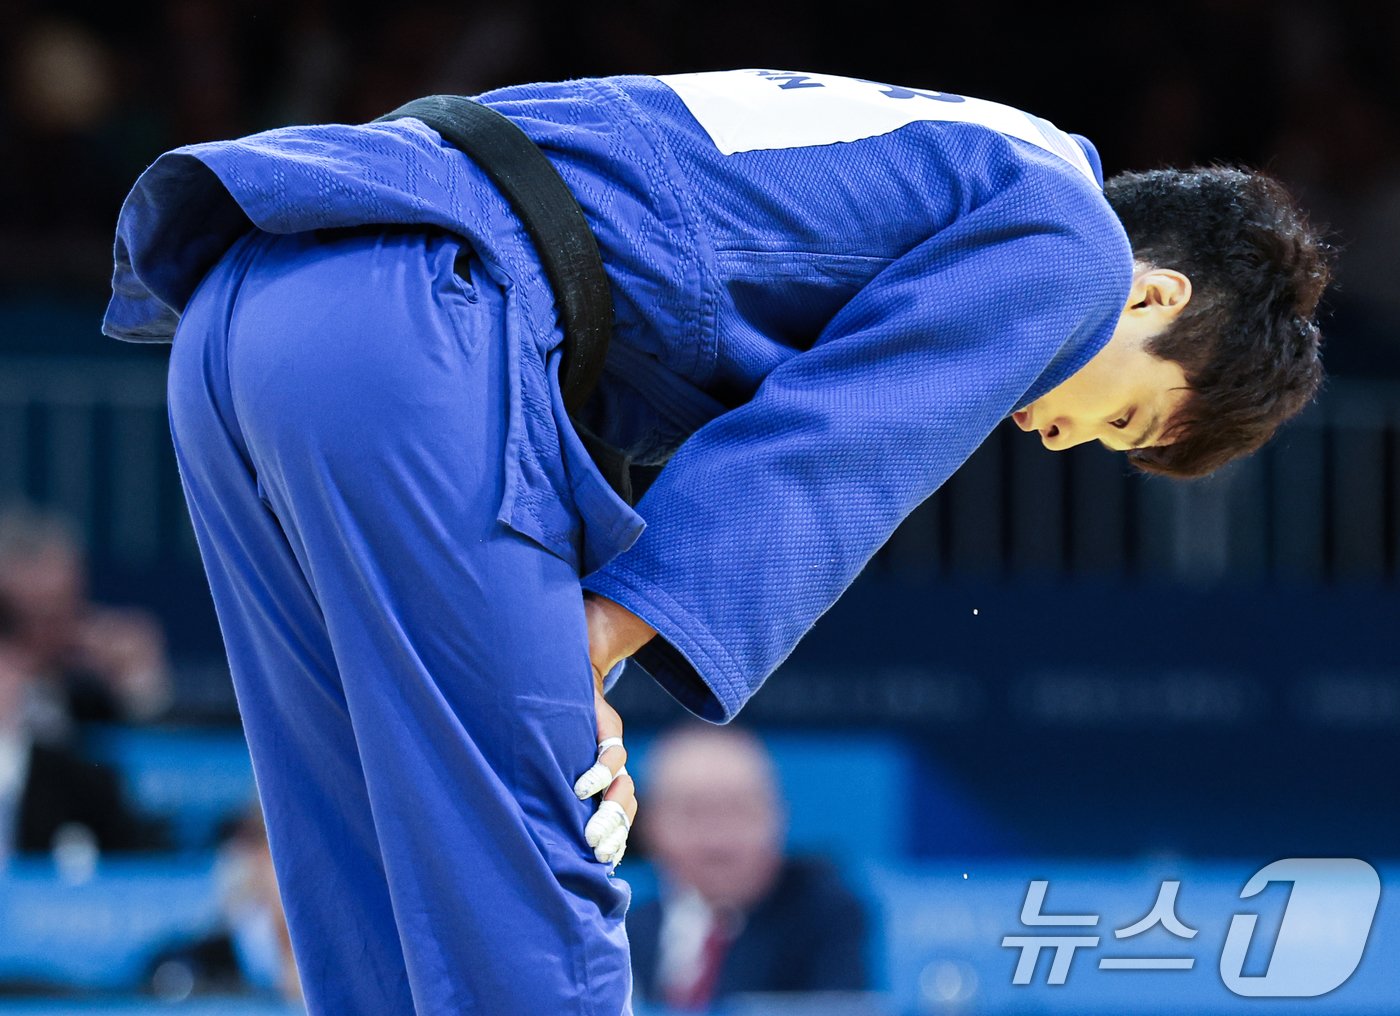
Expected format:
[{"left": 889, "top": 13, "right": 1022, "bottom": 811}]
[{"left": 0, "top": 0, "right": 1400, "bottom": 1016}]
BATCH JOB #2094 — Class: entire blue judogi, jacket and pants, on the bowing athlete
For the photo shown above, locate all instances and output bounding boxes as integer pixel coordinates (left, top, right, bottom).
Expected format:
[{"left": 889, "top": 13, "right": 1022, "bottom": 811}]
[{"left": 104, "top": 71, "right": 1131, "bottom": 1016}]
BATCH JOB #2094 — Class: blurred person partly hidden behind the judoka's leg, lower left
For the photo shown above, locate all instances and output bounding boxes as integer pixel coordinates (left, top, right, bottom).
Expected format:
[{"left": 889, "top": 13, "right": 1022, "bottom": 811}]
[{"left": 148, "top": 805, "right": 301, "bottom": 1002}]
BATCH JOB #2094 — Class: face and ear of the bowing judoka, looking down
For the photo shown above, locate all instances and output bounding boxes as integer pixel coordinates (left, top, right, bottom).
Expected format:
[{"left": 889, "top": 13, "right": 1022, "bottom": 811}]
[{"left": 1012, "top": 266, "right": 1191, "bottom": 452}]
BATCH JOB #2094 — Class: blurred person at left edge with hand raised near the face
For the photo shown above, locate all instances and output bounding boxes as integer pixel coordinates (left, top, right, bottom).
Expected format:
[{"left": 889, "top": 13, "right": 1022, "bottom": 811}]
[{"left": 0, "top": 505, "right": 172, "bottom": 742}]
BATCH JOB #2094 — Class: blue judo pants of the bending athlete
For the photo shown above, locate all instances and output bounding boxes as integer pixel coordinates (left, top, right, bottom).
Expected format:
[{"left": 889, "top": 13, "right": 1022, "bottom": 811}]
[{"left": 169, "top": 230, "right": 631, "bottom": 1016}]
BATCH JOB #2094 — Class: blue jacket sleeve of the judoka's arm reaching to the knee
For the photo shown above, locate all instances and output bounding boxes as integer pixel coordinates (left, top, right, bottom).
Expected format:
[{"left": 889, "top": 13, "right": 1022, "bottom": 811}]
[{"left": 582, "top": 174, "right": 1133, "bottom": 722}]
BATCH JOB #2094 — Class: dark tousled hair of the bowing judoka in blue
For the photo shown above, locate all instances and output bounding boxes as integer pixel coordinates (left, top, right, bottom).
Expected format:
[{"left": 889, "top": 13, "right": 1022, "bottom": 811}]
[{"left": 1103, "top": 165, "right": 1331, "bottom": 477}]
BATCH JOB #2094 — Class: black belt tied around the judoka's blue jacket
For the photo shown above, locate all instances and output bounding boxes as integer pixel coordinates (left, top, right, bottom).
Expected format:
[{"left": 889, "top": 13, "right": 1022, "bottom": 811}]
[{"left": 375, "top": 95, "right": 631, "bottom": 504}]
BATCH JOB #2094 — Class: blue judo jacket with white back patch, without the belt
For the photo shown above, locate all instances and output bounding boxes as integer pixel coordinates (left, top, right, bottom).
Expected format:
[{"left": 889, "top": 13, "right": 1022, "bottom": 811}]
[{"left": 104, "top": 70, "right": 1133, "bottom": 721}]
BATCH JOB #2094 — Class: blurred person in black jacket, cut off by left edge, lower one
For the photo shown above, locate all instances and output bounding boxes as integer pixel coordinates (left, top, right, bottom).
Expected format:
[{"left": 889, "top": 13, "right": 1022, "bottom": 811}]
[{"left": 0, "top": 601, "right": 162, "bottom": 866}]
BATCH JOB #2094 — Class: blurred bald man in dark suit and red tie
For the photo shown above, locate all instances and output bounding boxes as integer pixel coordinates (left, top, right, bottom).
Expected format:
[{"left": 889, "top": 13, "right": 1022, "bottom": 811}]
[{"left": 627, "top": 725, "right": 869, "bottom": 1010}]
